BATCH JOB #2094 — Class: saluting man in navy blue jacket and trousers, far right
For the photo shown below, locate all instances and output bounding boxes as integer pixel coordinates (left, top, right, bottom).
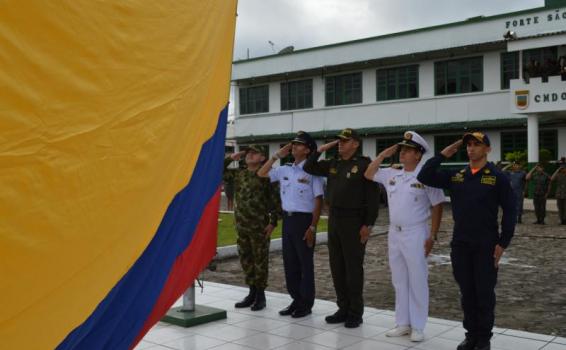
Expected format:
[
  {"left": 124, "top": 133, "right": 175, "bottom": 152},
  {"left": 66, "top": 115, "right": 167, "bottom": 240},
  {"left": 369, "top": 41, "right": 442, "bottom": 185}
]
[{"left": 417, "top": 132, "right": 517, "bottom": 350}]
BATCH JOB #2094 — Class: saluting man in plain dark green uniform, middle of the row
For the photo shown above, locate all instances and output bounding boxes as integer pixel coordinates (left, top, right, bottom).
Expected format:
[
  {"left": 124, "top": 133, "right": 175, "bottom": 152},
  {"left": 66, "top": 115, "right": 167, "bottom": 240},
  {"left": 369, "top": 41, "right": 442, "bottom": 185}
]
[{"left": 304, "top": 128, "right": 379, "bottom": 328}]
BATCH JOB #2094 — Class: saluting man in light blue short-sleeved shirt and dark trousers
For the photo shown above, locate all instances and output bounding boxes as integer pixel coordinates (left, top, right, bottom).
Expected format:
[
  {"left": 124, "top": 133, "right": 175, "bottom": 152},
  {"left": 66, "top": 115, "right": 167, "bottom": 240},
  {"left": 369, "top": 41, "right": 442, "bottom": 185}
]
[{"left": 258, "top": 131, "right": 324, "bottom": 318}]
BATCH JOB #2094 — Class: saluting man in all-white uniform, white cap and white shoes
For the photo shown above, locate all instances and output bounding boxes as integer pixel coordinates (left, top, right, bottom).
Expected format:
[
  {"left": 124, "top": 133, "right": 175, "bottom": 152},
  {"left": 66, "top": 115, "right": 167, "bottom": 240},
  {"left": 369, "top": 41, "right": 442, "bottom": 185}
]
[{"left": 364, "top": 131, "right": 444, "bottom": 342}]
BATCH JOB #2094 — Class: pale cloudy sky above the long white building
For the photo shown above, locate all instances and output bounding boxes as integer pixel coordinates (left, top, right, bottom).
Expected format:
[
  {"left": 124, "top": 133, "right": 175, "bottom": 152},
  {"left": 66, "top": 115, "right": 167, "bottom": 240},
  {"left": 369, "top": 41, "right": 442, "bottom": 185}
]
[{"left": 230, "top": 0, "right": 544, "bottom": 115}]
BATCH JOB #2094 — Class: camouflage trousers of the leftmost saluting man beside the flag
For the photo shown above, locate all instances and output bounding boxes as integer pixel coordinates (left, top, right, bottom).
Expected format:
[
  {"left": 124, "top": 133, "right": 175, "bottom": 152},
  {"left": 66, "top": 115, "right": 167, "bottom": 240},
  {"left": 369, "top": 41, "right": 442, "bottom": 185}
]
[{"left": 238, "top": 227, "right": 270, "bottom": 289}]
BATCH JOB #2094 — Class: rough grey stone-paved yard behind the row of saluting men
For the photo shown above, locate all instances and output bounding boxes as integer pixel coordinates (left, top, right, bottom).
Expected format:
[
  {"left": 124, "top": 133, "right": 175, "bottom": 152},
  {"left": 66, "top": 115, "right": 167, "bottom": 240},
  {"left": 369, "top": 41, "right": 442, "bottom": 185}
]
[{"left": 204, "top": 209, "right": 566, "bottom": 337}]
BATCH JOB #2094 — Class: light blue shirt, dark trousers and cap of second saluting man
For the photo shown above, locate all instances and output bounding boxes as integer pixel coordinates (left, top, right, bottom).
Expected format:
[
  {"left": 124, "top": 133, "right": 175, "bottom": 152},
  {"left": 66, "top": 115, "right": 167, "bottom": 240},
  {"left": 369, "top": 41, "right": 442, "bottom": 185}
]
[{"left": 269, "top": 132, "right": 324, "bottom": 317}]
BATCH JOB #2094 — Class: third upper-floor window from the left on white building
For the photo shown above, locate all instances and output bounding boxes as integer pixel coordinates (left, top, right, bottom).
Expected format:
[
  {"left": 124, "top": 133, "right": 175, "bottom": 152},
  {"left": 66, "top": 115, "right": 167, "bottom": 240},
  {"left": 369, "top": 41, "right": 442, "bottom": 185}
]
[{"left": 326, "top": 73, "right": 362, "bottom": 106}]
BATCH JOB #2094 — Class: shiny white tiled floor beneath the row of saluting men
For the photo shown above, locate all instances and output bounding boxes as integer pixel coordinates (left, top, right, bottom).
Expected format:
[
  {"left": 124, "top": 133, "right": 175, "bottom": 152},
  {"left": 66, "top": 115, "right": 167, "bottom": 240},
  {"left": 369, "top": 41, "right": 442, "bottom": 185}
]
[{"left": 136, "top": 282, "right": 566, "bottom": 350}]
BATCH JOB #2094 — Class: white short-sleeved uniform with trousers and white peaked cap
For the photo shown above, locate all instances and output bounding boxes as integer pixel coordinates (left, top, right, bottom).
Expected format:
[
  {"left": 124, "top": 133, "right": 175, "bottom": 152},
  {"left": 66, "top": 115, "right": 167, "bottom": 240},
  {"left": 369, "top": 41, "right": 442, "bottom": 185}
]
[{"left": 373, "top": 131, "right": 444, "bottom": 331}]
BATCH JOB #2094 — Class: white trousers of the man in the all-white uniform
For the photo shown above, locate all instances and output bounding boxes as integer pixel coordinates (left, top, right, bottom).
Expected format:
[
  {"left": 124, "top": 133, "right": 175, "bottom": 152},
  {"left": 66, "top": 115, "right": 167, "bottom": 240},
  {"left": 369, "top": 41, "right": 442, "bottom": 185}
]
[{"left": 388, "top": 223, "right": 430, "bottom": 331}]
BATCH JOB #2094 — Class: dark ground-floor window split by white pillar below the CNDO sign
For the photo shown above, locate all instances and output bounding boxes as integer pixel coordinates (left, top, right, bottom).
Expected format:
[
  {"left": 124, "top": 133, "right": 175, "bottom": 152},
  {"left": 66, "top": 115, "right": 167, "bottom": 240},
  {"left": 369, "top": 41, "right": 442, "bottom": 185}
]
[{"left": 501, "top": 130, "right": 558, "bottom": 159}]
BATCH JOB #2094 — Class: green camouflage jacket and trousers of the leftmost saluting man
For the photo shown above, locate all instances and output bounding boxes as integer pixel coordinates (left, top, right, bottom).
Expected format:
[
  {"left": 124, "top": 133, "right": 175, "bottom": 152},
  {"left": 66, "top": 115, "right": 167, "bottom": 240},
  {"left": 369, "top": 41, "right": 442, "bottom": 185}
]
[{"left": 224, "top": 158, "right": 280, "bottom": 289}]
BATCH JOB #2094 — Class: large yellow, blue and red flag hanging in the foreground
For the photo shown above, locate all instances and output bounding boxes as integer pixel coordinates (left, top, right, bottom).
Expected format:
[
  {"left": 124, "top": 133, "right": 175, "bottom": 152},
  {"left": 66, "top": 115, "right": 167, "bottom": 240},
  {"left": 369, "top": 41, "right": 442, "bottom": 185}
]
[{"left": 0, "top": 0, "right": 236, "bottom": 350}]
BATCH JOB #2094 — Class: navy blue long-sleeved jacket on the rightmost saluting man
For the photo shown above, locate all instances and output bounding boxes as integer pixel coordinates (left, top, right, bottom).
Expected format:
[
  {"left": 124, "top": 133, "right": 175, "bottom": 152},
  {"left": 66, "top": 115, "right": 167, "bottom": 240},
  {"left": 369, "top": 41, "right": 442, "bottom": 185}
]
[{"left": 417, "top": 155, "right": 517, "bottom": 248}]
